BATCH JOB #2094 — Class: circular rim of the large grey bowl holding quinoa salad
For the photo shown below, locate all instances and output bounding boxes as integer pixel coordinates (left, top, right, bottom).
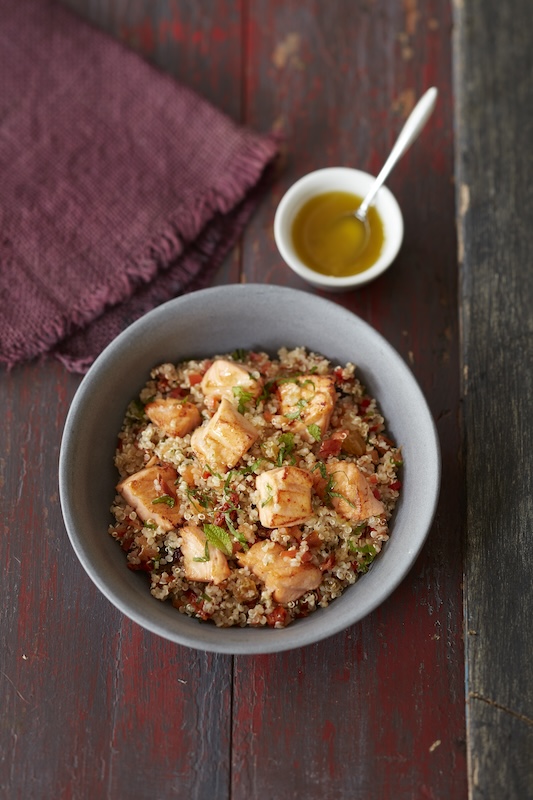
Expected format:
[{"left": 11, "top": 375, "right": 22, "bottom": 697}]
[{"left": 59, "top": 283, "right": 441, "bottom": 655}]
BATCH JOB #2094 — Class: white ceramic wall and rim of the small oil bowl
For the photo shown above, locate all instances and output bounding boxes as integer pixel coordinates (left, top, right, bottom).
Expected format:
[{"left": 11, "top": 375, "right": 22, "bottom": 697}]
[{"left": 274, "top": 167, "right": 404, "bottom": 290}]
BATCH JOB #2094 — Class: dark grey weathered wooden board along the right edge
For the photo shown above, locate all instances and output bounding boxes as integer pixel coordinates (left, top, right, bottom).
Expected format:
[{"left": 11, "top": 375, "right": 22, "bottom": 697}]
[{"left": 456, "top": 0, "right": 533, "bottom": 800}]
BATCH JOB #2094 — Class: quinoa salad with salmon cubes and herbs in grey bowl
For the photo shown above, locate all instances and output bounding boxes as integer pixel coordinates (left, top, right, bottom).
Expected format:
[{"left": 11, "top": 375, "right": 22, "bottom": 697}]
[{"left": 109, "top": 347, "right": 402, "bottom": 628}]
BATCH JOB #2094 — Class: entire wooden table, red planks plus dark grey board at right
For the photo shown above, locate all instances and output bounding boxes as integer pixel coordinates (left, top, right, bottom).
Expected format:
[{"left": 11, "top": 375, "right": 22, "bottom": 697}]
[{"left": 0, "top": 0, "right": 533, "bottom": 800}]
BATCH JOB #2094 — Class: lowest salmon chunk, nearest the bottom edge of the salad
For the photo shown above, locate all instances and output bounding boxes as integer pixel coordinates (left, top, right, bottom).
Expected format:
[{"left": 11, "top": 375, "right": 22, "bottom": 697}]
[{"left": 237, "top": 541, "right": 322, "bottom": 603}]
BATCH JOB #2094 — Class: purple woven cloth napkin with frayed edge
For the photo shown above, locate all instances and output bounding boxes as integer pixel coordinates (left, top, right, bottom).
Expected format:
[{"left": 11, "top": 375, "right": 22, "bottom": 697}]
[{"left": 0, "top": 0, "right": 276, "bottom": 372}]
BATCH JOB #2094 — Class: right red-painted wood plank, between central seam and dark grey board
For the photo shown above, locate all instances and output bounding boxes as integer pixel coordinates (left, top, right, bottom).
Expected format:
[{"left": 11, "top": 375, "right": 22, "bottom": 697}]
[{"left": 232, "top": 0, "right": 466, "bottom": 800}]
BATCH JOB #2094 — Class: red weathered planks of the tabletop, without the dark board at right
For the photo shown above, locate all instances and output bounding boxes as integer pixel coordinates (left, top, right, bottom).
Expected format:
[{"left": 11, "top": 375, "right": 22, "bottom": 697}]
[{"left": 0, "top": 0, "right": 467, "bottom": 800}]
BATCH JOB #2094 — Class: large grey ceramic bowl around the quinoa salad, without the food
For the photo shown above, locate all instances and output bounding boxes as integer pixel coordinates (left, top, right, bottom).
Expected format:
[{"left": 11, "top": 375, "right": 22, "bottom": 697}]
[{"left": 59, "top": 285, "right": 440, "bottom": 654}]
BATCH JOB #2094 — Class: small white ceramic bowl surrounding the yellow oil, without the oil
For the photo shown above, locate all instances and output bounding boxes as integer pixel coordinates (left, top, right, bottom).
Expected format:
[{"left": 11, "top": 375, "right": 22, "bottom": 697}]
[{"left": 274, "top": 167, "right": 403, "bottom": 290}]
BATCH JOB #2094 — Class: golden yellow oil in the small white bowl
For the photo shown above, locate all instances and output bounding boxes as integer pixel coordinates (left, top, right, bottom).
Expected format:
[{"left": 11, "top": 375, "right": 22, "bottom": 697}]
[{"left": 292, "top": 192, "right": 383, "bottom": 278}]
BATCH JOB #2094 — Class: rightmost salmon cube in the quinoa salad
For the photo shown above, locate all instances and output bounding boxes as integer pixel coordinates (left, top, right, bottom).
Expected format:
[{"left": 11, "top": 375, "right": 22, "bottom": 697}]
[{"left": 326, "top": 461, "right": 385, "bottom": 522}]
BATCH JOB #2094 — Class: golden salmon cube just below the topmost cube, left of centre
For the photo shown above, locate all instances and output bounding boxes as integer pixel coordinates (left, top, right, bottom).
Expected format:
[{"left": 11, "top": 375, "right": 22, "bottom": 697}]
[{"left": 191, "top": 398, "right": 259, "bottom": 469}]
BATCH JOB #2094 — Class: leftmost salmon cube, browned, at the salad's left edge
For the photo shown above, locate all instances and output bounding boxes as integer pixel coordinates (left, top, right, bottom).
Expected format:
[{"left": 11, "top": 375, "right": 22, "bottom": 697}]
[{"left": 117, "top": 465, "right": 182, "bottom": 531}]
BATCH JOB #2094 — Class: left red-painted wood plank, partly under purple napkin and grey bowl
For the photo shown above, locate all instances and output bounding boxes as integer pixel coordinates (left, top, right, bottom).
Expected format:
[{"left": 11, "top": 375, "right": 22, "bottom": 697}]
[{"left": 0, "top": 0, "right": 241, "bottom": 800}]
